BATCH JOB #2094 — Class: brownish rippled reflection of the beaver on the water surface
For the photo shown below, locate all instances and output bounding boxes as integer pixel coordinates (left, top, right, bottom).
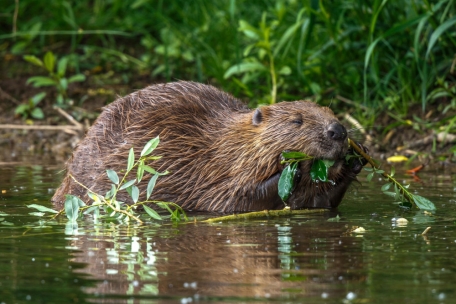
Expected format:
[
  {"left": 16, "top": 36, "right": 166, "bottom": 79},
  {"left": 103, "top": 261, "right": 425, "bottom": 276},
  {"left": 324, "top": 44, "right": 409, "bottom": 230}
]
[{"left": 71, "top": 216, "right": 364, "bottom": 300}]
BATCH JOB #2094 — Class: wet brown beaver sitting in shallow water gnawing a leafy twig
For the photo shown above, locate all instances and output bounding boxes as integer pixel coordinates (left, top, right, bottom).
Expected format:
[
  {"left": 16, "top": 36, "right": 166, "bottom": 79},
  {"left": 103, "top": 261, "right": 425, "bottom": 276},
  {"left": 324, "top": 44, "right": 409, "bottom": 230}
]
[{"left": 52, "top": 81, "right": 364, "bottom": 213}]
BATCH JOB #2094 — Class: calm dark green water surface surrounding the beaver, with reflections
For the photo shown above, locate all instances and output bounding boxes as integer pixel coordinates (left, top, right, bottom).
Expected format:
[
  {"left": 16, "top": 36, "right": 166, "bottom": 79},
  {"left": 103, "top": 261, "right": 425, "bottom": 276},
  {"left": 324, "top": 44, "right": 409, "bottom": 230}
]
[{"left": 0, "top": 160, "right": 456, "bottom": 304}]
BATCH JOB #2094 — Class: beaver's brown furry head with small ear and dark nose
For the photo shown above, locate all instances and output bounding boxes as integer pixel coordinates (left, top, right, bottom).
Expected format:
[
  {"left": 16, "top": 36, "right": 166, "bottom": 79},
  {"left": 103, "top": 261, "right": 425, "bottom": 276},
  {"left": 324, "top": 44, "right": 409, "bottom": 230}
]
[{"left": 252, "top": 101, "right": 348, "bottom": 160}]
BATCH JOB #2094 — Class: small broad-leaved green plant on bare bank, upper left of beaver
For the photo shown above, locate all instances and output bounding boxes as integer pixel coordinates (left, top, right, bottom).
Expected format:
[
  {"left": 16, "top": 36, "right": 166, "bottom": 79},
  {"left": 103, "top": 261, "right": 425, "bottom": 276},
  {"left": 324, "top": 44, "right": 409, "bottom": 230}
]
[{"left": 24, "top": 51, "right": 85, "bottom": 108}]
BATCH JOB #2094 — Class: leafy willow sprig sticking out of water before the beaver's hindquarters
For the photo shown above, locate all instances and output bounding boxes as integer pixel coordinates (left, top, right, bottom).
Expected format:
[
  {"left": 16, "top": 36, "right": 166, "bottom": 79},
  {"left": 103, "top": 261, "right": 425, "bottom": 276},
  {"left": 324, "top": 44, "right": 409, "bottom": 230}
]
[{"left": 28, "top": 137, "right": 187, "bottom": 223}]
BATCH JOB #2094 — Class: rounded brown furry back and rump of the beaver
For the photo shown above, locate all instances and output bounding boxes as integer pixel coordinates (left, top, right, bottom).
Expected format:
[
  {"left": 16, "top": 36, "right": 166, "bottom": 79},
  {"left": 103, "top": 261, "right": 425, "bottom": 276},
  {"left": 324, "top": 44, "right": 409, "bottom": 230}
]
[{"left": 52, "top": 82, "right": 253, "bottom": 205}]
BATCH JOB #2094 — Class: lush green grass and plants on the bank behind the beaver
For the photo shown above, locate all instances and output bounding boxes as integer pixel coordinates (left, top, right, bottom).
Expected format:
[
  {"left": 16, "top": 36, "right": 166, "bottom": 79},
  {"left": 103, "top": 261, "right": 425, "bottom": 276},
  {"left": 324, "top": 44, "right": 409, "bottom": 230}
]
[{"left": 0, "top": 0, "right": 456, "bottom": 146}]
